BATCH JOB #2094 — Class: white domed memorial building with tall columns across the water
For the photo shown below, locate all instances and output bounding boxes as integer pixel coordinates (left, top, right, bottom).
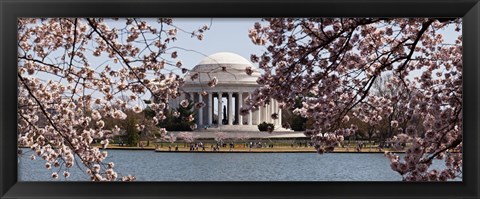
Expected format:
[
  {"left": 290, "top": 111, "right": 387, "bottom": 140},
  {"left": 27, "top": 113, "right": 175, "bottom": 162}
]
[{"left": 170, "top": 52, "right": 285, "bottom": 131}]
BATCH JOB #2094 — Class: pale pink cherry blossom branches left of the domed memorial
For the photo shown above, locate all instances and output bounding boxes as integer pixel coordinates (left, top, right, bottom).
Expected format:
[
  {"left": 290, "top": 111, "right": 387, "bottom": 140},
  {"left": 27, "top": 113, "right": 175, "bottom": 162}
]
[{"left": 17, "top": 18, "right": 208, "bottom": 181}]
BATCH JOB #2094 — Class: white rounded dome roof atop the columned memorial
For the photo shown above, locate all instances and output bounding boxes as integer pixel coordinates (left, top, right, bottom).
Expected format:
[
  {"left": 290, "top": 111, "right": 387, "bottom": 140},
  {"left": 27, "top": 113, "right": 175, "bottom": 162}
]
[{"left": 185, "top": 52, "right": 260, "bottom": 84}]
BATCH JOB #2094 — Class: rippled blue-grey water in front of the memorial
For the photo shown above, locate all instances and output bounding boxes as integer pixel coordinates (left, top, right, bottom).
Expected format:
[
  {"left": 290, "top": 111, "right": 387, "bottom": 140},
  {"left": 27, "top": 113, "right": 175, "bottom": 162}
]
[{"left": 18, "top": 150, "right": 454, "bottom": 181}]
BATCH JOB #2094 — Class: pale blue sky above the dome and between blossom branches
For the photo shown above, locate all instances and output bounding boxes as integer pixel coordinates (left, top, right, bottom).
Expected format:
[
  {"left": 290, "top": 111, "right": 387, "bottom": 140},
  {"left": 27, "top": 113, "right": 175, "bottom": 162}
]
[{"left": 24, "top": 18, "right": 459, "bottom": 112}]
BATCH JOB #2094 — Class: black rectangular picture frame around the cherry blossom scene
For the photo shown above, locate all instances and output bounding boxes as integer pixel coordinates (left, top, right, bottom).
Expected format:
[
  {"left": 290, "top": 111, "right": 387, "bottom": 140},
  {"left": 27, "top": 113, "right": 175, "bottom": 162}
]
[{"left": 0, "top": 0, "right": 480, "bottom": 199}]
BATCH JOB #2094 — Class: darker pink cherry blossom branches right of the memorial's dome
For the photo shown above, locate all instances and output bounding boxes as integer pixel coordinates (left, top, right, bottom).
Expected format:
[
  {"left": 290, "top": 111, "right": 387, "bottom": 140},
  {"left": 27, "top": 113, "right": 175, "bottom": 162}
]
[{"left": 243, "top": 18, "right": 463, "bottom": 181}]
